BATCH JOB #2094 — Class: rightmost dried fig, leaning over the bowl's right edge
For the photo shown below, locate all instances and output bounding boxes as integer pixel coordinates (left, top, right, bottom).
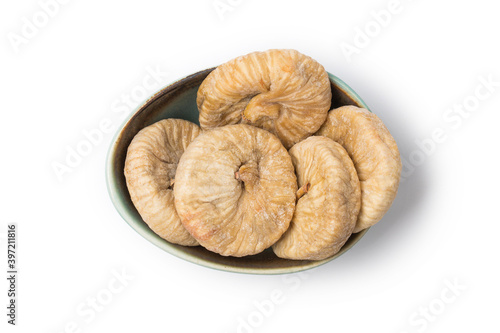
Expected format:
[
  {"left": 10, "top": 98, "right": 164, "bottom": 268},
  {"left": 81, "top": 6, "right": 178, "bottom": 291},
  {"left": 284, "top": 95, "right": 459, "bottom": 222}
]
[{"left": 317, "top": 106, "right": 401, "bottom": 232}]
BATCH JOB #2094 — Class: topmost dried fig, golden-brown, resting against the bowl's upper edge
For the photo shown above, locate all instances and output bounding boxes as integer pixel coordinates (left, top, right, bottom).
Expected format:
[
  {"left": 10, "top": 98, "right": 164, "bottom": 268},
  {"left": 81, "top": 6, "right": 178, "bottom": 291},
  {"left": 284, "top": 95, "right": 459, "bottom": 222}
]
[{"left": 197, "top": 50, "right": 332, "bottom": 149}]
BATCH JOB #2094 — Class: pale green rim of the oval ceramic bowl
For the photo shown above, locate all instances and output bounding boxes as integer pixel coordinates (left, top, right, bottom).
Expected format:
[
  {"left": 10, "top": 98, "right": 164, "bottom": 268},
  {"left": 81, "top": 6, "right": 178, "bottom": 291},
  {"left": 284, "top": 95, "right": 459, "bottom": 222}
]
[{"left": 105, "top": 67, "right": 370, "bottom": 275}]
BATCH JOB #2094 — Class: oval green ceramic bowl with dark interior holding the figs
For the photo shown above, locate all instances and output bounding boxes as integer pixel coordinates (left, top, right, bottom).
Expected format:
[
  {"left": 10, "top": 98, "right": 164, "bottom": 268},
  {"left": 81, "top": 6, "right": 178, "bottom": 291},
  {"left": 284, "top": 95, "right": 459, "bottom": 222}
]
[{"left": 106, "top": 68, "right": 368, "bottom": 274}]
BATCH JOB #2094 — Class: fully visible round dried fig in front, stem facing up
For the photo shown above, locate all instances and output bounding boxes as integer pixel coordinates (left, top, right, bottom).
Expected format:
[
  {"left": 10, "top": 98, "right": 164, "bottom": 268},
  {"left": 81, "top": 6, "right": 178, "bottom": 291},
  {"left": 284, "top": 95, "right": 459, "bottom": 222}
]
[{"left": 174, "top": 124, "right": 297, "bottom": 257}]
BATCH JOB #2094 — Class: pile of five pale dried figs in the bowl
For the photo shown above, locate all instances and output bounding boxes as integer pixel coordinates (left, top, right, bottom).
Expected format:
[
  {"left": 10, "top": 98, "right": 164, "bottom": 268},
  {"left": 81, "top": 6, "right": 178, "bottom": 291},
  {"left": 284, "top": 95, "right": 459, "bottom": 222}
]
[{"left": 125, "top": 50, "right": 401, "bottom": 260}]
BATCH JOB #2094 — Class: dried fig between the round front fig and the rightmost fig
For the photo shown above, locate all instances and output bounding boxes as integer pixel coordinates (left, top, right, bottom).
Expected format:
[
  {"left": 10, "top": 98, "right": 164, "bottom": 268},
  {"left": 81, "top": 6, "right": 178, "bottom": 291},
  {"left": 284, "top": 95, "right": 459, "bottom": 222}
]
[{"left": 273, "top": 136, "right": 361, "bottom": 260}]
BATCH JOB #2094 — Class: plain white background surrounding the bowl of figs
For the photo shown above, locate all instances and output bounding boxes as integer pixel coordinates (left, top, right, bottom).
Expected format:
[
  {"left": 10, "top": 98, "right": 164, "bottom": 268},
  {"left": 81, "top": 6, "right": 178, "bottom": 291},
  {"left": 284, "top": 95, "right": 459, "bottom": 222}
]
[{"left": 0, "top": 0, "right": 500, "bottom": 333}]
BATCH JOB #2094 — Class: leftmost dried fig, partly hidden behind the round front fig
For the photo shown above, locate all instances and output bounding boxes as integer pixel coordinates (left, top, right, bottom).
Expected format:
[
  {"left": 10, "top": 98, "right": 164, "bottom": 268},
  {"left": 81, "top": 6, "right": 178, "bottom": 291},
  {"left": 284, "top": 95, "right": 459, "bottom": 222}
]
[{"left": 125, "top": 119, "right": 200, "bottom": 246}]
